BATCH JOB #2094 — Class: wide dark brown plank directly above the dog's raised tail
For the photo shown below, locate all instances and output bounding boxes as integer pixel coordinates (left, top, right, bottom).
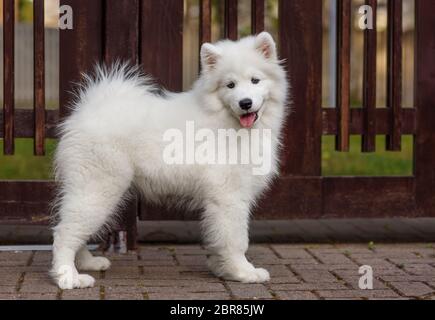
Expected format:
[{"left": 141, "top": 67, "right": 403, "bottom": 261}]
[{"left": 59, "top": 0, "right": 103, "bottom": 118}]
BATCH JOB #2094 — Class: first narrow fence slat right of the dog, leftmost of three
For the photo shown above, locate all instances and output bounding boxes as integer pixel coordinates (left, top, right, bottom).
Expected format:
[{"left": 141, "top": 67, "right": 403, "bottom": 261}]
[{"left": 336, "top": 0, "right": 352, "bottom": 151}]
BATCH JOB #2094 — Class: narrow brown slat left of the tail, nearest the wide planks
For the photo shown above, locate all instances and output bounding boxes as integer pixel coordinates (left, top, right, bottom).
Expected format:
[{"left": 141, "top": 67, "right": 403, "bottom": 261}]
[{"left": 33, "top": 0, "right": 45, "bottom": 156}]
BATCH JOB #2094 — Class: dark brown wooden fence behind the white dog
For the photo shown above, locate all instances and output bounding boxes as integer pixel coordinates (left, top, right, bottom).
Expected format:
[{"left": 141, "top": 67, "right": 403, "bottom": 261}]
[{"left": 0, "top": 0, "right": 435, "bottom": 246}]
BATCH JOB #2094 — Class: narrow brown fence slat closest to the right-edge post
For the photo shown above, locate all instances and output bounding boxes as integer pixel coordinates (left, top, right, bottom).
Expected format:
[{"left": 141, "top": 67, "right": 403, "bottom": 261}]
[{"left": 387, "top": 0, "right": 403, "bottom": 151}]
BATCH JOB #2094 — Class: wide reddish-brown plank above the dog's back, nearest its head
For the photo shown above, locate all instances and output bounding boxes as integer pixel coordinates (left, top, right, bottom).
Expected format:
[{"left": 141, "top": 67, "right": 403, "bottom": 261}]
[{"left": 140, "top": 0, "right": 184, "bottom": 91}]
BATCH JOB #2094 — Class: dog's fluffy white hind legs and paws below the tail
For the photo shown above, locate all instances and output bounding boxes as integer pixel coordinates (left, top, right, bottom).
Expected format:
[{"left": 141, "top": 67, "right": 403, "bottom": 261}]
[{"left": 51, "top": 176, "right": 130, "bottom": 289}]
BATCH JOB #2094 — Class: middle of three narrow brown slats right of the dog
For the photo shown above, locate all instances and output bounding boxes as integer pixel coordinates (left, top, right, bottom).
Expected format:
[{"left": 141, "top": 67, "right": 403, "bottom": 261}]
[{"left": 362, "top": 0, "right": 378, "bottom": 152}]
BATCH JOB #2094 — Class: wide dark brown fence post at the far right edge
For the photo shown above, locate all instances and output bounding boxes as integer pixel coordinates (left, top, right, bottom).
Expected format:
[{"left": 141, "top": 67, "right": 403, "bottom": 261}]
[{"left": 414, "top": 0, "right": 435, "bottom": 217}]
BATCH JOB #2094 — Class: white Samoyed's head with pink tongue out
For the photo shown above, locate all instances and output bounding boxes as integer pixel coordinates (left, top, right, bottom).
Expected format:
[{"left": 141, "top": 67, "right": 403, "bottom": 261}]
[{"left": 201, "top": 32, "right": 287, "bottom": 128}]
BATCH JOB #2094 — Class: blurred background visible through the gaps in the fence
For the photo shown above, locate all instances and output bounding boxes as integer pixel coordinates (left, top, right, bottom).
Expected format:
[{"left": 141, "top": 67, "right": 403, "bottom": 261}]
[{"left": 0, "top": 0, "right": 414, "bottom": 180}]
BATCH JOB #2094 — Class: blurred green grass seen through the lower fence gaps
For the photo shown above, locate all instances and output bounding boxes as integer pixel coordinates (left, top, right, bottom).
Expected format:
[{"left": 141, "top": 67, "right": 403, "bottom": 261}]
[{"left": 0, "top": 136, "right": 413, "bottom": 180}]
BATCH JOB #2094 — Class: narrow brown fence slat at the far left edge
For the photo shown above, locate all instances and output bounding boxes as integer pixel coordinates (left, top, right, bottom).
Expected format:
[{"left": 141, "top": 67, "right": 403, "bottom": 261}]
[{"left": 3, "top": 0, "right": 15, "bottom": 155}]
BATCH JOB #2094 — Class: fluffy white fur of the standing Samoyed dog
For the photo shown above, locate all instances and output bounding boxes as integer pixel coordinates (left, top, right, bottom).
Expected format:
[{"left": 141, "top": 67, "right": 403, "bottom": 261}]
[{"left": 51, "top": 32, "right": 288, "bottom": 289}]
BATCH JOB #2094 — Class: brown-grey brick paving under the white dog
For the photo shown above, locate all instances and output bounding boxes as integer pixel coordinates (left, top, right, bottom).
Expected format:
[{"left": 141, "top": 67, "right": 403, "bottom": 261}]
[{"left": 0, "top": 243, "right": 435, "bottom": 300}]
